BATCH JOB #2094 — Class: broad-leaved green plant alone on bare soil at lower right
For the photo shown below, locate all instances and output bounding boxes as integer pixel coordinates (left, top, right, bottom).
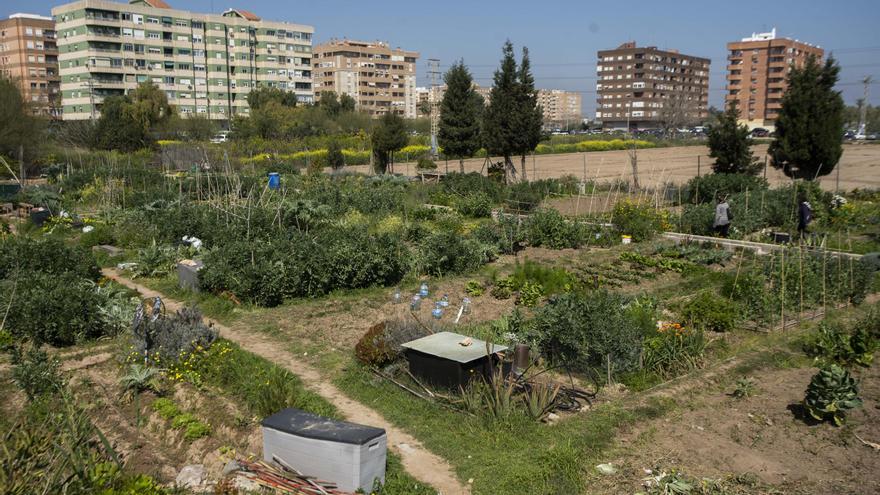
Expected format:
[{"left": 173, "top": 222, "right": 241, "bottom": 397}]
[{"left": 804, "top": 364, "right": 862, "bottom": 426}]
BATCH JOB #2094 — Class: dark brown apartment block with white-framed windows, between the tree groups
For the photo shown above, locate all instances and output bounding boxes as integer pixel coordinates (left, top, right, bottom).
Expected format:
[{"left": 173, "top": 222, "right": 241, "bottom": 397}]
[{"left": 596, "top": 41, "right": 710, "bottom": 129}]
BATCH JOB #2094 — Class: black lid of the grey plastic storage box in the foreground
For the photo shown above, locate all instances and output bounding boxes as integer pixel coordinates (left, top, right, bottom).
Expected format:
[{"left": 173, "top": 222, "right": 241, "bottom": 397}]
[{"left": 262, "top": 408, "right": 385, "bottom": 445}]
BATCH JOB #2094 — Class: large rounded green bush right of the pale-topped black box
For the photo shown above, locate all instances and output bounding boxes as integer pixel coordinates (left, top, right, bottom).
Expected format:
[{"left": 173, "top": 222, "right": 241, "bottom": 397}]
[{"left": 527, "top": 291, "right": 650, "bottom": 375}]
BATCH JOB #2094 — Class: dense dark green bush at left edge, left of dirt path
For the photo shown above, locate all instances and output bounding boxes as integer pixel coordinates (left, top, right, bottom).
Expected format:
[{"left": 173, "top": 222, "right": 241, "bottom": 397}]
[{"left": 0, "top": 272, "right": 111, "bottom": 347}]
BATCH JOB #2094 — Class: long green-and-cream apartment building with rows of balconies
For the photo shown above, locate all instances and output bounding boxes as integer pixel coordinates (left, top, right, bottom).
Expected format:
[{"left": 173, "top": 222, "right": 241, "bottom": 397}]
[{"left": 52, "top": 0, "right": 314, "bottom": 120}]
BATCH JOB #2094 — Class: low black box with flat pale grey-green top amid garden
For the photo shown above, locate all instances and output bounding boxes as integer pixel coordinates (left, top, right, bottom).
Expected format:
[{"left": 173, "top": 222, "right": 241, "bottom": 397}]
[{"left": 402, "top": 332, "right": 507, "bottom": 388}]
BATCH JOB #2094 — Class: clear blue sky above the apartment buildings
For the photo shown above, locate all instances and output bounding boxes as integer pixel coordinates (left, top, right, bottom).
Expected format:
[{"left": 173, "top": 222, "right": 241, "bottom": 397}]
[{"left": 0, "top": 0, "right": 880, "bottom": 116}]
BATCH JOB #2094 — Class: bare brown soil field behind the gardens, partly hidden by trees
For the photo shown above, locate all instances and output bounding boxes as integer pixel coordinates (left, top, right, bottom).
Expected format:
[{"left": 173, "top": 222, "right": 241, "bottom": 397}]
[{"left": 350, "top": 144, "right": 880, "bottom": 190}]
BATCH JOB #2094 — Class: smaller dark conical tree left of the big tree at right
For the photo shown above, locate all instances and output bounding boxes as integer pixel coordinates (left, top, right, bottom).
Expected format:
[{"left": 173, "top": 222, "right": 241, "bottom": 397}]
[{"left": 708, "top": 100, "right": 760, "bottom": 174}]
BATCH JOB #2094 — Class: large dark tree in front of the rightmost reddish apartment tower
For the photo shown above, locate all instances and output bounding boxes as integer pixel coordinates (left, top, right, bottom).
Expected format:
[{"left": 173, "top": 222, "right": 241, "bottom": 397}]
[{"left": 768, "top": 56, "right": 844, "bottom": 180}]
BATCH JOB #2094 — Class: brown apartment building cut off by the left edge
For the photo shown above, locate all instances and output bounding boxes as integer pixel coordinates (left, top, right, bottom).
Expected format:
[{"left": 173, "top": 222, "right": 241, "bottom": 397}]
[{"left": 0, "top": 14, "right": 61, "bottom": 117}]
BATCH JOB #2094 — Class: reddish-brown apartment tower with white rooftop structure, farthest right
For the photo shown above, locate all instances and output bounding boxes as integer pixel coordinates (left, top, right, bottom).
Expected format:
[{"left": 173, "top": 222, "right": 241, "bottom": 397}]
[{"left": 726, "top": 28, "right": 825, "bottom": 130}]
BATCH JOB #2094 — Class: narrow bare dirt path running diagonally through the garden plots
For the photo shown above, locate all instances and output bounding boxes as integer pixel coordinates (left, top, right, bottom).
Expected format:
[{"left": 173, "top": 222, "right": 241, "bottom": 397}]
[{"left": 103, "top": 268, "right": 470, "bottom": 495}]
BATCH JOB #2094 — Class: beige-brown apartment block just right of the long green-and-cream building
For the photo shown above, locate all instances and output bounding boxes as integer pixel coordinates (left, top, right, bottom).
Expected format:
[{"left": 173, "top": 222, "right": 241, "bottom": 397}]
[{"left": 313, "top": 40, "right": 419, "bottom": 118}]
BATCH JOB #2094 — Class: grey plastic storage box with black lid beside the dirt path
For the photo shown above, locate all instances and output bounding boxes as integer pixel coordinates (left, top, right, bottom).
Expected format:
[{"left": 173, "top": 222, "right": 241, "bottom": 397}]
[{"left": 262, "top": 409, "right": 388, "bottom": 493}]
